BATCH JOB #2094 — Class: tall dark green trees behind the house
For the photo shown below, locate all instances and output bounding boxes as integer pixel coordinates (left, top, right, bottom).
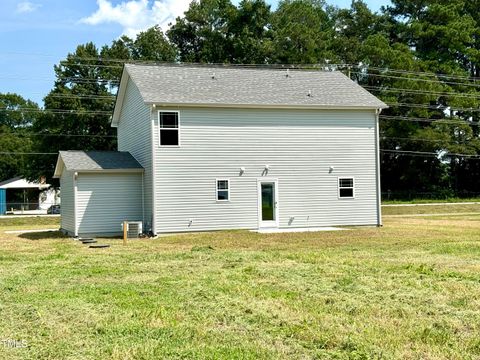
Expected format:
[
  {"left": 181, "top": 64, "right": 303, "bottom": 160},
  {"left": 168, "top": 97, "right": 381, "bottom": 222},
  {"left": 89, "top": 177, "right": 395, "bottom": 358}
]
[{"left": 0, "top": 0, "right": 480, "bottom": 198}]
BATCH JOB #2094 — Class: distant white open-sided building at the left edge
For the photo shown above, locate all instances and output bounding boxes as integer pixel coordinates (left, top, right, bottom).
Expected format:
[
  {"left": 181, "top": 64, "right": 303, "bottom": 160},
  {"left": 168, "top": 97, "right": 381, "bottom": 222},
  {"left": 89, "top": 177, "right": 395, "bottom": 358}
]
[{"left": 0, "top": 177, "right": 60, "bottom": 215}]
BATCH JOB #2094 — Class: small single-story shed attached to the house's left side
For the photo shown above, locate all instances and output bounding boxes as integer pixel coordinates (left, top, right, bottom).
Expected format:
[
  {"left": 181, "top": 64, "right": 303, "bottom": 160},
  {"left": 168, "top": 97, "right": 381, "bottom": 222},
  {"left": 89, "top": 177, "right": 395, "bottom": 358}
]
[{"left": 54, "top": 151, "right": 144, "bottom": 236}]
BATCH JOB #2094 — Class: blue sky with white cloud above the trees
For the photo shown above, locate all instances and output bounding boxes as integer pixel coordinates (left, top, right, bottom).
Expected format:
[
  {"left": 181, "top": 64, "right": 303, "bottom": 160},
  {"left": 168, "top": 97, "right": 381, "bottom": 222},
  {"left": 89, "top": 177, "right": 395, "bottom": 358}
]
[{"left": 0, "top": 0, "right": 389, "bottom": 105}]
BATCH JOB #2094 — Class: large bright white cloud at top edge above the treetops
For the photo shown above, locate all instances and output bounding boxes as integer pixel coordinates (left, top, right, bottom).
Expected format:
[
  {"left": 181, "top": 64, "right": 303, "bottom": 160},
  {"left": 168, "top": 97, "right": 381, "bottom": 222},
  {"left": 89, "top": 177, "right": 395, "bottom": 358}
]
[{"left": 80, "top": 0, "right": 191, "bottom": 38}]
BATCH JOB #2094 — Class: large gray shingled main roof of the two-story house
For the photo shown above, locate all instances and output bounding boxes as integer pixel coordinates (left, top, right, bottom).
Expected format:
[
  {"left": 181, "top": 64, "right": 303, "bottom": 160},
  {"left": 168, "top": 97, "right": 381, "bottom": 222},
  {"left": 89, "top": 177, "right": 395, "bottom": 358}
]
[{"left": 125, "top": 64, "right": 387, "bottom": 108}]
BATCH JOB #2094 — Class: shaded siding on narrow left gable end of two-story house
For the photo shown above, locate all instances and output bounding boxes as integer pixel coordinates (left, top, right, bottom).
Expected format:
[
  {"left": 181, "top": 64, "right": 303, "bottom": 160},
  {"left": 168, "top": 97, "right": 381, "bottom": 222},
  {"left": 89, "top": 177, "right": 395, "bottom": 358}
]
[{"left": 117, "top": 80, "right": 153, "bottom": 231}]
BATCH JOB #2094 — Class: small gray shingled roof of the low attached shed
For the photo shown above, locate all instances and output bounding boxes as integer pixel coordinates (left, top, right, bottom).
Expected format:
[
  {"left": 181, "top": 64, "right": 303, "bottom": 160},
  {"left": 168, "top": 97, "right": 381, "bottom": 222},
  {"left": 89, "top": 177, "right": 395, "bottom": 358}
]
[{"left": 60, "top": 151, "right": 143, "bottom": 171}]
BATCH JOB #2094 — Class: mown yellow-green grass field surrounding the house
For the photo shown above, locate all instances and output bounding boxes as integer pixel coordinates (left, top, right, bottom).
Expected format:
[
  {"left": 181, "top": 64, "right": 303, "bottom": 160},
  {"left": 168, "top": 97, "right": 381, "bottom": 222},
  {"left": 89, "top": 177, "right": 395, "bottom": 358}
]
[{"left": 0, "top": 207, "right": 480, "bottom": 359}]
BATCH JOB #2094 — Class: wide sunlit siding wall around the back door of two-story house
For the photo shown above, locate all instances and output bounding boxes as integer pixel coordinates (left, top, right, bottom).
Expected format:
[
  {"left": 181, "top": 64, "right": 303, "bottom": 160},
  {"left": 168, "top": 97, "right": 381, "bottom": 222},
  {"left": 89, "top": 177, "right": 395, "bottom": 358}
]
[{"left": 152, "top": 108, "right": 377, "bottom": 233}]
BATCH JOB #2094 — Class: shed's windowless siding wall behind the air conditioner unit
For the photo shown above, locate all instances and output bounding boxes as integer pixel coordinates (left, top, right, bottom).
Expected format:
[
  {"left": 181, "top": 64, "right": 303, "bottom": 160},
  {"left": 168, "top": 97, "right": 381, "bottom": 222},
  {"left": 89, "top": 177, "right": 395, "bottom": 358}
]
[{"left": 76, "top": 173, "right": 142, "bottom": 236}]
